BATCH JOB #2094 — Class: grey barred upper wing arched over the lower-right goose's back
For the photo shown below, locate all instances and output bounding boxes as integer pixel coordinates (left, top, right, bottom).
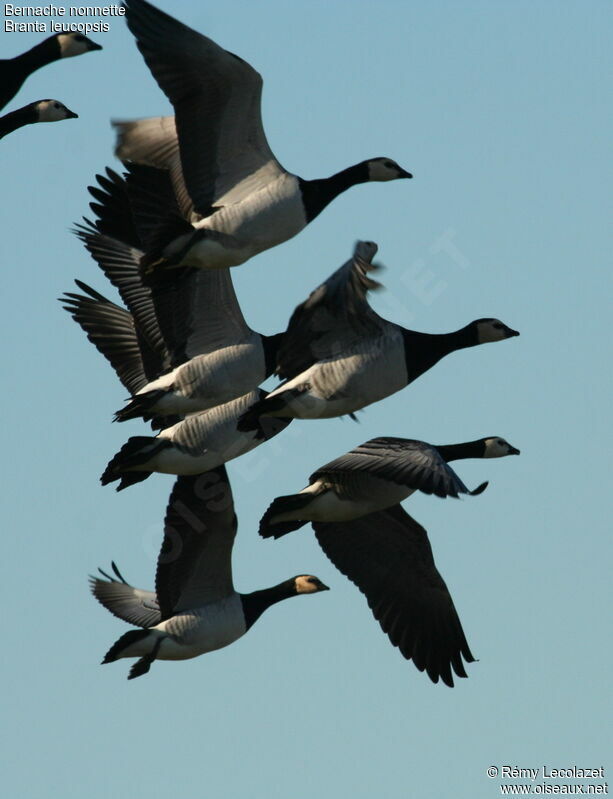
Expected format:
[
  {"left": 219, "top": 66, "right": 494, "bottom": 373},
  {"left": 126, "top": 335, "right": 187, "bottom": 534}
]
[{"left": 309, "top": 436, "right": 469, "bottom": 497}]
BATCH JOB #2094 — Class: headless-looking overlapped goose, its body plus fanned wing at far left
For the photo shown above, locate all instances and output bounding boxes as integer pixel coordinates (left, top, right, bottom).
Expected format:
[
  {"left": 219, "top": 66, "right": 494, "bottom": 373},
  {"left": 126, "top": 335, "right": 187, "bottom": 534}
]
[{"left": 60, "top": 281, "right": 291, "bottom": 491}]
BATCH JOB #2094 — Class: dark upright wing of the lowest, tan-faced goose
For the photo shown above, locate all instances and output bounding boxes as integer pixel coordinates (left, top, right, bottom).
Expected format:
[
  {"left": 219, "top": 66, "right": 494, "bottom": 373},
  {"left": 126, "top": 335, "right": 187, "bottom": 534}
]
[{"left": 155, "top": 467, "right": 237, "bottom": 620}]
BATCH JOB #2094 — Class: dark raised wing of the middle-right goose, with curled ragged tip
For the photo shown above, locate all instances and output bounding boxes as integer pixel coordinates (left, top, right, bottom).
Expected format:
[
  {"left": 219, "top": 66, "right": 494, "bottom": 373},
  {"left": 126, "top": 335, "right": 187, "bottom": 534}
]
[{"left": 277, "top": 241, "right": 386, "bottom": 379}]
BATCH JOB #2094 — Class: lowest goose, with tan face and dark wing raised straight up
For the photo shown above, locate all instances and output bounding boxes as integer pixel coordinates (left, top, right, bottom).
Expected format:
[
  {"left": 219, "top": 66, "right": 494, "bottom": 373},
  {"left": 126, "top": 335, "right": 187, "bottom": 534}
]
[{"left": 90, "top": 467, "right": 328, "bottom": 680}]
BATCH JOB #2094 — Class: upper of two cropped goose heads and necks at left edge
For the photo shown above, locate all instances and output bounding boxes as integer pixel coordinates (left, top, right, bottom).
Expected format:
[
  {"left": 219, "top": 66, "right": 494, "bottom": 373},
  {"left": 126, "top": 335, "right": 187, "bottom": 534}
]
[{"left": 0, "top": 33, "right": 102, "bottom": 108}]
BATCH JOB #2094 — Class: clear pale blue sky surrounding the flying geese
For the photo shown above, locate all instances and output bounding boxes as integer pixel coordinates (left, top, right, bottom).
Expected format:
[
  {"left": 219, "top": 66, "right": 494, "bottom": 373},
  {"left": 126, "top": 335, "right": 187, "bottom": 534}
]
[{"left": 0, "top": 0, "right": 612, "bottom": 799}]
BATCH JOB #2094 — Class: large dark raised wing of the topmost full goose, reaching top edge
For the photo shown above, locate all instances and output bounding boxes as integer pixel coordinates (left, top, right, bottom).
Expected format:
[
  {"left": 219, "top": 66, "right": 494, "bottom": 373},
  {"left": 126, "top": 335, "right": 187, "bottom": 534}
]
[{"left": 124, "top": 0, "right": 283, "bottom": 216}]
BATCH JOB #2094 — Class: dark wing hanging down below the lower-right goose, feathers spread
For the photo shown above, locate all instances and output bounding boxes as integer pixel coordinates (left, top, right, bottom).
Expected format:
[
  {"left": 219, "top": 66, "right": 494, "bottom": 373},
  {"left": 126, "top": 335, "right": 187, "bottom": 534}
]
[{"left": 313, "top": 505, "right": 475, "bottom": 688}]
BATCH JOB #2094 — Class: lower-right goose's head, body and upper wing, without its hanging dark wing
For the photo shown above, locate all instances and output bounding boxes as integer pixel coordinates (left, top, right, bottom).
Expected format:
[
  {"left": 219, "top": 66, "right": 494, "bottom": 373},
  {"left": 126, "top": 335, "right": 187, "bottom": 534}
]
[{"left": 260, "top": 436, "right": 519, "bottom": 538}]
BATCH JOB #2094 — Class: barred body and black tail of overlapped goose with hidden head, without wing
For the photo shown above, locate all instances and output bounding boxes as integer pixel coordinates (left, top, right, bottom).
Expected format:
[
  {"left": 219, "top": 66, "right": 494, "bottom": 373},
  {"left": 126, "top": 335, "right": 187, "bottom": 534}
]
[{"left": 100, "top": 389, "right": 291, "bottom": 491}]
